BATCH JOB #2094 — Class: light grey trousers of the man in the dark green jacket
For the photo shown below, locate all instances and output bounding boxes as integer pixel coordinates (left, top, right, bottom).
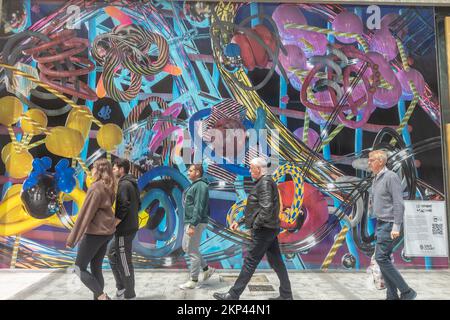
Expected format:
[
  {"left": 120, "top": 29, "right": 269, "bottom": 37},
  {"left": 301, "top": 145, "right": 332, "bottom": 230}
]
[{"left": 182, "top": 223, "right": 208, "bottom": 281}]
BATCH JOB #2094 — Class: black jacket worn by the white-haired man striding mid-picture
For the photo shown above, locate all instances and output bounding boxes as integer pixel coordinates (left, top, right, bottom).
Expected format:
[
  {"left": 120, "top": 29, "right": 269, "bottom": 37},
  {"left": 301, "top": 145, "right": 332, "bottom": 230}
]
[{"left": 244, "top": 175, "right": 280, "bottom": 229}]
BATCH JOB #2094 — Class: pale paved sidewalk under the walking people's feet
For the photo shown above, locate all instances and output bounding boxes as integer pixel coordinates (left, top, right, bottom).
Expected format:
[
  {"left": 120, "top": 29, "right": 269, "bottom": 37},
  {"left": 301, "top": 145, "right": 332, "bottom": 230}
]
[{"left": 0, "top": 270, "right": 450, "bottom": 300}]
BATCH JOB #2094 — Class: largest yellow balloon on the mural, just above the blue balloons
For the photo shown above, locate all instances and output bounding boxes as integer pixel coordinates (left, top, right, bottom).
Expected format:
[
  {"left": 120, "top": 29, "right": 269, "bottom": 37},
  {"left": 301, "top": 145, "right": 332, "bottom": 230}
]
[{"left": 45, "top": 127, "right": 84, "bottom": 158}]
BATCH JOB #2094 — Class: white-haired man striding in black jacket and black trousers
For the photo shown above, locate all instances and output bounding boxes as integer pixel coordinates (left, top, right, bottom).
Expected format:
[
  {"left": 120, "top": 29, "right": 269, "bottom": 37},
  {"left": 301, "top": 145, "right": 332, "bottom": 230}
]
[{"left": 213, "top": 158, "right": 293, "bottom": 300}]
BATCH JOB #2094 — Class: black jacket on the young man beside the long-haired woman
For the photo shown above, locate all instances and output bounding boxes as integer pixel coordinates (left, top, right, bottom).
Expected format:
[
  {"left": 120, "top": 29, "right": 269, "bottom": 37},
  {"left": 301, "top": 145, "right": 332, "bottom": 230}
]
[{"left": 116, "top": 174, "right": 141, "bottom": 236}]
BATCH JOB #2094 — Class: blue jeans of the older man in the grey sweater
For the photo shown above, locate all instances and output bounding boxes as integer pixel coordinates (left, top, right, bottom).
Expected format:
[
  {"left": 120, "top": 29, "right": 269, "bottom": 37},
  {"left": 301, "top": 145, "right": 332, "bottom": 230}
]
[{"left": 375, "top": 220, "right": 409, "bottom": 299}]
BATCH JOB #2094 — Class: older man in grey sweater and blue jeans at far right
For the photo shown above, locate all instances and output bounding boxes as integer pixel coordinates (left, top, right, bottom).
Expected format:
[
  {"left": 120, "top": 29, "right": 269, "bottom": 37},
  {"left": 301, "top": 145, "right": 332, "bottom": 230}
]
[{"left": 369, "top": 150, "right": 417, "bottom": 300}]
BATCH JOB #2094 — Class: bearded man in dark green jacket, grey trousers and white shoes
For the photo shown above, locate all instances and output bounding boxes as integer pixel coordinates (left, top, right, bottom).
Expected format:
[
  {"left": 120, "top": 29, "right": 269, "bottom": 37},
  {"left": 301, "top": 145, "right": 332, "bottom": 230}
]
[{"left": 180, "top": 164, "right": 215, "bottom": 290}]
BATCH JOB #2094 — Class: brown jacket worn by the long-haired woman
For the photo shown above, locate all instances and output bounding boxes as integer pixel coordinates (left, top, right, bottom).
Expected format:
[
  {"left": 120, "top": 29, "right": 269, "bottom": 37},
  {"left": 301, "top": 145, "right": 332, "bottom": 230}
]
[{"left": 67, "top": 181, "right": 116, "bottom": 248}]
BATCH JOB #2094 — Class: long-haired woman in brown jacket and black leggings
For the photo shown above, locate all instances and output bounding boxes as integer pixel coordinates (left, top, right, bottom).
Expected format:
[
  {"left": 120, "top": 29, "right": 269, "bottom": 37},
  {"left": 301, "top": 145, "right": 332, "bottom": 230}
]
[{"left": 67, "top": 159, "right": 116, "bottom": 300}]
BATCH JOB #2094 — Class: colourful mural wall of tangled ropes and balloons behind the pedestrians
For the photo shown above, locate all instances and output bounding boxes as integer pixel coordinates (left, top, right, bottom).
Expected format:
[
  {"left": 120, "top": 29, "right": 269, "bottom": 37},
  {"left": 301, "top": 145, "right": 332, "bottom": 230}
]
[{"left": 0, "top": 0, "right": 447, "bottom": 270}]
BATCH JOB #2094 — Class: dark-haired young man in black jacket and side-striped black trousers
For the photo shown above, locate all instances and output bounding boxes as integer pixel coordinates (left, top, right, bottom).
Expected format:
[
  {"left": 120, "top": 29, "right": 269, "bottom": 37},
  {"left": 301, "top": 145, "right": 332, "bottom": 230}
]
[{"left": 108, "top": 159, "right": 141, "bottom": 299}]
